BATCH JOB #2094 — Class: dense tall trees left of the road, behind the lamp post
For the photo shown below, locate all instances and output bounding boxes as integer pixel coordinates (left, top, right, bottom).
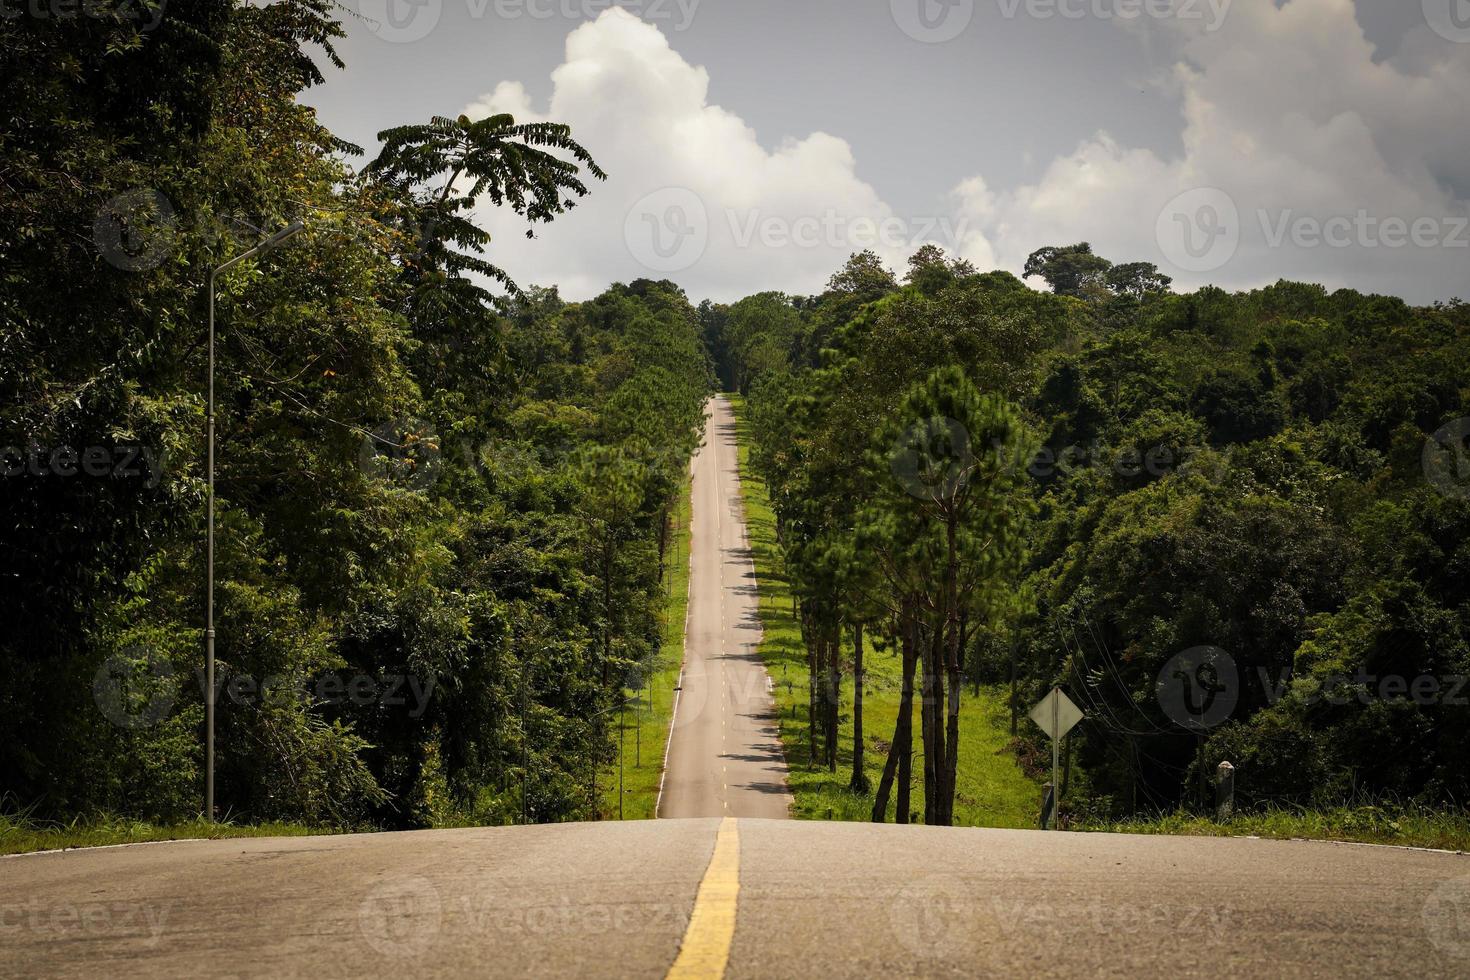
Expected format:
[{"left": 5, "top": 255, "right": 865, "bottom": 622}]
[{"left": 0, "top": 0, "right": 710, "bottom": 826}]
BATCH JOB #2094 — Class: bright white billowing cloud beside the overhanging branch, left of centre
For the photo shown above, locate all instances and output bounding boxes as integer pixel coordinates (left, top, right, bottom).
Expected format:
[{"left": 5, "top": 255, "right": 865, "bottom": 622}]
[{"left": 466, "top": 7, "right": 941, "bottom": 300}]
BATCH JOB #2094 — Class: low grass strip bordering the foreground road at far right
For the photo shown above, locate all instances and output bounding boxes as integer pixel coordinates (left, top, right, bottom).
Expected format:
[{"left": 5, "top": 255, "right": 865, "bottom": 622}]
[{"left": 1078, "top": 805, "right": 1470, "bottom": 851}]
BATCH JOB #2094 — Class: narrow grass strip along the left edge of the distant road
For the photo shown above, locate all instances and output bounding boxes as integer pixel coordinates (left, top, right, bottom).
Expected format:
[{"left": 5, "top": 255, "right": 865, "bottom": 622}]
[{"left": 598, "top": 475, "right": 692, "bottom": 820}]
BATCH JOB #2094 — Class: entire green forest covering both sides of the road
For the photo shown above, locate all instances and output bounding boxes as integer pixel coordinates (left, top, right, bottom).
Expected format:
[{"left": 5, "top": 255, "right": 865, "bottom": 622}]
[{"left": 0, "top": 0, "right": 1470, "bottom": 827}]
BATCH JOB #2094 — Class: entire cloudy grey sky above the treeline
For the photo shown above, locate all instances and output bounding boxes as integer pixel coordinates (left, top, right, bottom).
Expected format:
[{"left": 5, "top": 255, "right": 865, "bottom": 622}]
[{"left": 307, "top": 0, "right": 1470, "bottom": 303}]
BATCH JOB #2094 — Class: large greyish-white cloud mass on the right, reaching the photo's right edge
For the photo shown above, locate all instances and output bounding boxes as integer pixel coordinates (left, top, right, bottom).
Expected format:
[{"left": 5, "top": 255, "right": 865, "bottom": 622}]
[{"left": 957, "top": 0, "right": 1470, "bottom": 301}]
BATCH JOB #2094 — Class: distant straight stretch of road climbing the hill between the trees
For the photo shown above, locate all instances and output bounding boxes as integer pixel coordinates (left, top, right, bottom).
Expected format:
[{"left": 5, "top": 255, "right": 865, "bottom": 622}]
[{"left": 659, "top": 398, "right": 791, "bottom": 817}]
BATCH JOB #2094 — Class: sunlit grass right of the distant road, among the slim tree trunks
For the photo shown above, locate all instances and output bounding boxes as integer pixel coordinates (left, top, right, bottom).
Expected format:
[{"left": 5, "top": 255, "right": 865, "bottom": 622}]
[{"left": 729, "top": 395, "right": 1041, "bottom": 827}]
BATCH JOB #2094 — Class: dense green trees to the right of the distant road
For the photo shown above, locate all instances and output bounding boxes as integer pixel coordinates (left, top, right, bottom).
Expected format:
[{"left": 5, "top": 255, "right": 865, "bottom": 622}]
[{"left": 729, "top": 244, "right": 1470, "bottom": 821}]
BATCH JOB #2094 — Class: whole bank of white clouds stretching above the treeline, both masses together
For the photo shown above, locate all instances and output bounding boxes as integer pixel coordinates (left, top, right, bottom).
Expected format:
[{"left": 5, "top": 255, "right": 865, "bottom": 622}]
[{"left": 466, "top": 0, "right": 1470, "bottom": 301}]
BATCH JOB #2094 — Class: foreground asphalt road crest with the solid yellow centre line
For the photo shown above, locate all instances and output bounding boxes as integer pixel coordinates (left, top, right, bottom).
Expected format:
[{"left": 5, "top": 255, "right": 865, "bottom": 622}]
[{"left": 0, "top": 818, "right": 1470, "bottom": 980}]
